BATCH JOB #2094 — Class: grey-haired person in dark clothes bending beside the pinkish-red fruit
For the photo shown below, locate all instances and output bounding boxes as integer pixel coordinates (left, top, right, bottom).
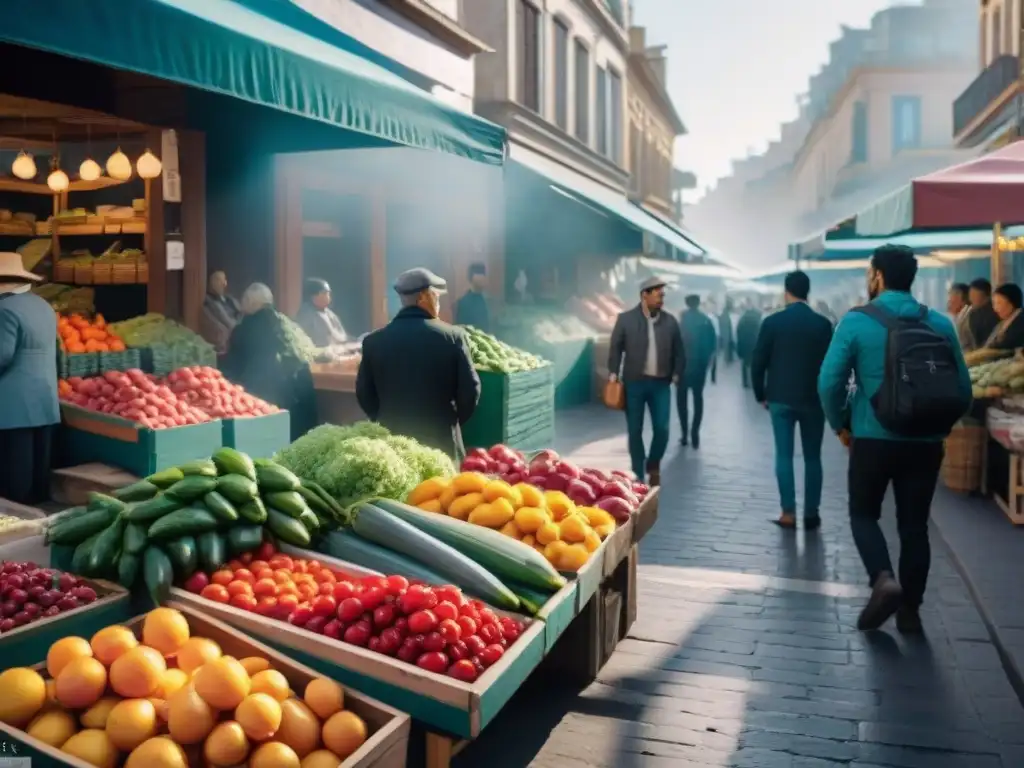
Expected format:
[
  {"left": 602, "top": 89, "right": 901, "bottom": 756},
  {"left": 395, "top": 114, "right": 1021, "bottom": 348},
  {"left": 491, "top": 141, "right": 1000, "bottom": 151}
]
[{"left": 221, "top": 283, "right": 316, "bottom": 440}]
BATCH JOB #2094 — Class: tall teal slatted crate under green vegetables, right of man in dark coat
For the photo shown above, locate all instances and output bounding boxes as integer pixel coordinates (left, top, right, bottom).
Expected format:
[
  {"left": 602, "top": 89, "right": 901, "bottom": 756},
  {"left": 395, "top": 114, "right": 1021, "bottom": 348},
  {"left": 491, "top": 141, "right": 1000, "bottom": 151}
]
[{"left": 462, "top": 366, "right": 555, "bottom": 450}]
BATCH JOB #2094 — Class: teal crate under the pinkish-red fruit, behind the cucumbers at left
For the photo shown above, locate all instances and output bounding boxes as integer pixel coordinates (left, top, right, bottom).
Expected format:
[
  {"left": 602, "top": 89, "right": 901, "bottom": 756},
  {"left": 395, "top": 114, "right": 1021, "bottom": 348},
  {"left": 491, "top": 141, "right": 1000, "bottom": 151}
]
[{"left": 61, "top": 403, "right": 223, "bottom": 477}]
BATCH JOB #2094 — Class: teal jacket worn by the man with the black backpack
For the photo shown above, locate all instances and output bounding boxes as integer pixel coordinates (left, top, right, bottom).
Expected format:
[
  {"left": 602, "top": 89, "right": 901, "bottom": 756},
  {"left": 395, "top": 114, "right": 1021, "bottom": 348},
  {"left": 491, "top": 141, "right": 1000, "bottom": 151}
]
[{"left": 818, "top": 291, "right": 971, "bottom": 441}]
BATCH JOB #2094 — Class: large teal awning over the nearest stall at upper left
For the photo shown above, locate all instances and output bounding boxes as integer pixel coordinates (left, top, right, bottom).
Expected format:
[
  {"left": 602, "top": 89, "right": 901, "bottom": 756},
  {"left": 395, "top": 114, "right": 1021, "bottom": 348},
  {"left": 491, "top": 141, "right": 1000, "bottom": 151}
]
[{"left": 0, "top": 0, "right": 506, "bottom": 165}]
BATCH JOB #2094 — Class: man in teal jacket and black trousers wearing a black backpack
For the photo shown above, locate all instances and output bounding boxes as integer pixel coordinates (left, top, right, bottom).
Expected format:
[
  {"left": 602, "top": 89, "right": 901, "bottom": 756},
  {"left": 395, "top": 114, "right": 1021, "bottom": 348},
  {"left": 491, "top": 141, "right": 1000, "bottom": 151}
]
[{"left": 818, "top": 245, "right": 971, "bottom": 634}]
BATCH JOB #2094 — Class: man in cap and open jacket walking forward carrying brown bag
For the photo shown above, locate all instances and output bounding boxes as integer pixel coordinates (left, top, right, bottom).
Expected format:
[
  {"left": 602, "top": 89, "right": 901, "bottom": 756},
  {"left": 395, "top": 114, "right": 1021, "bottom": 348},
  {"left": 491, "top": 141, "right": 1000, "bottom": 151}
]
[{"left": 608, "top": 278, "right": 684, "bottom": 485}]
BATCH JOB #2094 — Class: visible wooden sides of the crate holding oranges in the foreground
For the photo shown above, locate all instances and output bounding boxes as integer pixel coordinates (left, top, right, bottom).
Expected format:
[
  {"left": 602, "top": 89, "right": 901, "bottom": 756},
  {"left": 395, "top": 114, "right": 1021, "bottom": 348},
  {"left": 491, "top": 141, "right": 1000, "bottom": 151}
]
[{"left": 0, "top": 602, "right": 410, "bottom": 768}]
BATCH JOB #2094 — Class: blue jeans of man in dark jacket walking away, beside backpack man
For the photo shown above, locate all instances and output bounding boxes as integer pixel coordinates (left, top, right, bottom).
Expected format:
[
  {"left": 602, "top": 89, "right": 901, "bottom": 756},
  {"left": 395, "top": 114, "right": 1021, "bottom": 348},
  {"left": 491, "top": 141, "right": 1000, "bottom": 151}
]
[{"left": 768, "top": 402, "right": 825, "bottom": 519}]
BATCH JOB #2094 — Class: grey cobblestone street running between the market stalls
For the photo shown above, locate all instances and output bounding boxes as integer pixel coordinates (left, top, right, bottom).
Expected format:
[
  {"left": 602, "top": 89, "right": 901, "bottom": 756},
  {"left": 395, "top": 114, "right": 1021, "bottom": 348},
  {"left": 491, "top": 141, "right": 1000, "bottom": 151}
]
[{"left": 458, "top": 365, "right": 1024, "bottom": 768}]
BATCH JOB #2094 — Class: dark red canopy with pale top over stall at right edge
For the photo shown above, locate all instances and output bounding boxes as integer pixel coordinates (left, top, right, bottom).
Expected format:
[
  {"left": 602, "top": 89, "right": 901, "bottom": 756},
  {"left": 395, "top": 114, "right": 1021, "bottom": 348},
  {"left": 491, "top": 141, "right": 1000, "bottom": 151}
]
[{"left": 911, "top": 141, "right": 1024, "bottom": 228}]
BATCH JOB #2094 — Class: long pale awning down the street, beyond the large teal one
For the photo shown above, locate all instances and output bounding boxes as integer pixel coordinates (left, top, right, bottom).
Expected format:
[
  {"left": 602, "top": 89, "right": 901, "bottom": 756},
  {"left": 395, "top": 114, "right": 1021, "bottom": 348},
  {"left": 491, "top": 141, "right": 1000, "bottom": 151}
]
[{"left": 509, "top": 141, "right": 706, "bottom": 261}]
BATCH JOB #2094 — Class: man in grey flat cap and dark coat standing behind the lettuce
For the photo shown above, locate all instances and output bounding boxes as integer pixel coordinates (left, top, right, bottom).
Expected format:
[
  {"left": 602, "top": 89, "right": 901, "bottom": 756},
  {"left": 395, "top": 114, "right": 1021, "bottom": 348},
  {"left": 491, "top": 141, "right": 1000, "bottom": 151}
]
[{"left": 355, "top": 267, "right": 480, "bottom": 462}]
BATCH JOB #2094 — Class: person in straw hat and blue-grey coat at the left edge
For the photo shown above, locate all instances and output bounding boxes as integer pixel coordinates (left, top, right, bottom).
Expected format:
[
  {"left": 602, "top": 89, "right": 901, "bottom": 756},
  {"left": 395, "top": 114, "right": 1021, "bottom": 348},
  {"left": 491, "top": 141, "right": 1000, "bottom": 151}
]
[{"left": 0, "top": 253, "right": 60, "bottom": 504}]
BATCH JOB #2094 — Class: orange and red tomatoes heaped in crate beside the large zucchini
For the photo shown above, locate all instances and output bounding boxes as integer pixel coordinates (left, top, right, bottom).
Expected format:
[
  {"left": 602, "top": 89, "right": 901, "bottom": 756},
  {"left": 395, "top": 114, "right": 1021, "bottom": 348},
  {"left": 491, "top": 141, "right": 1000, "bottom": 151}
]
[{"left": 186, "top": 545, "right": 525, "bottom": 682}]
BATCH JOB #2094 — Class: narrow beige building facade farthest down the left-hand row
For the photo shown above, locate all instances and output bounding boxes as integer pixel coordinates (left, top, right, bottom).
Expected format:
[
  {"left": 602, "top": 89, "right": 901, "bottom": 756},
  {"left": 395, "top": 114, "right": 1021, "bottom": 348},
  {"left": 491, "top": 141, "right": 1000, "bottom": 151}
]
[{"left": 628, "top": 27, "right": 686, "bottom": 220}]
